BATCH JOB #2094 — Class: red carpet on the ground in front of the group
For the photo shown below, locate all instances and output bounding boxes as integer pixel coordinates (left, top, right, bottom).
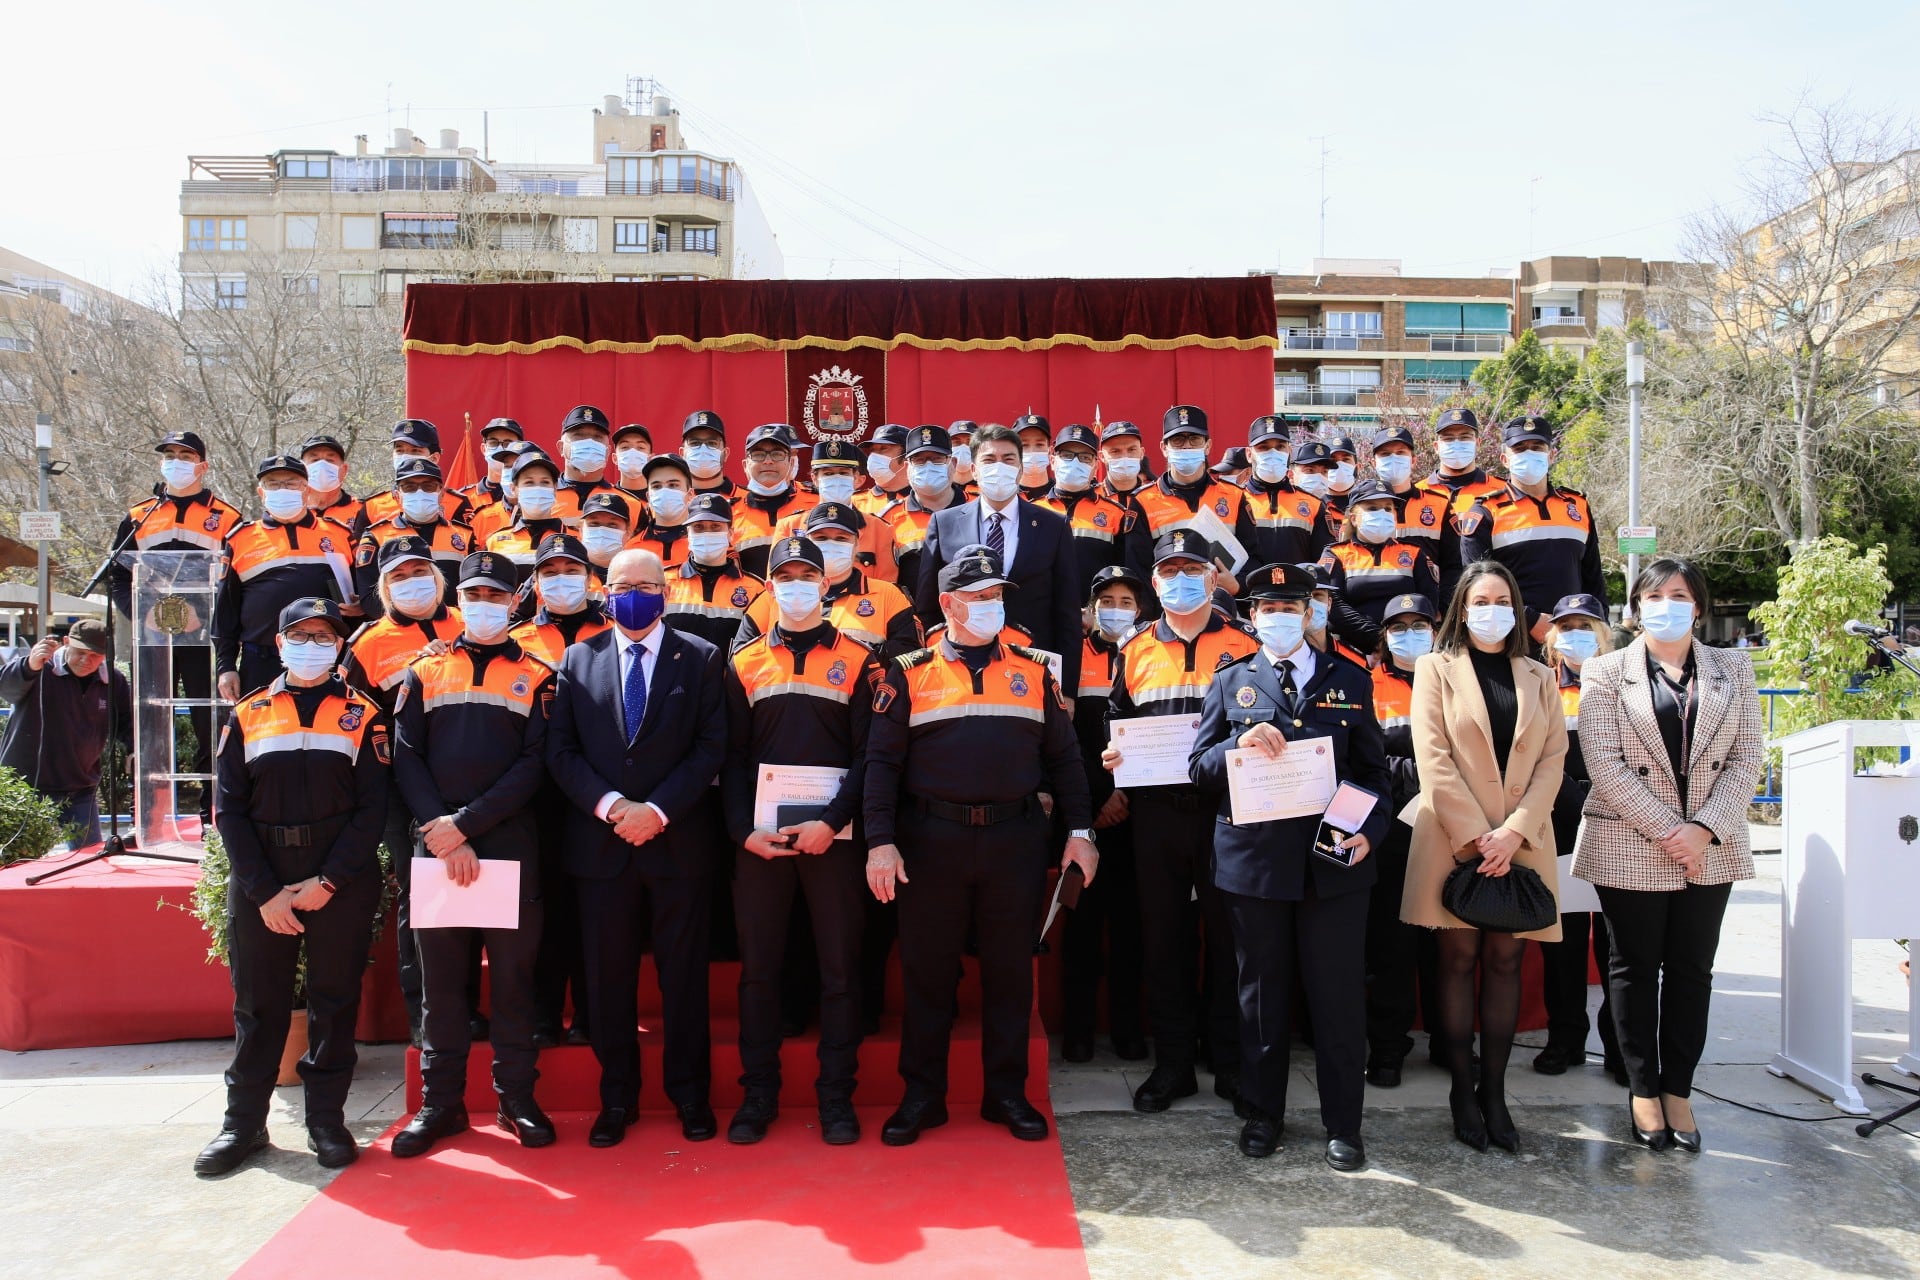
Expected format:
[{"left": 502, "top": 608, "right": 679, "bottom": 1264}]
[{"left": 236, "top": 1090, "right": 1087, "bottom": 1280}]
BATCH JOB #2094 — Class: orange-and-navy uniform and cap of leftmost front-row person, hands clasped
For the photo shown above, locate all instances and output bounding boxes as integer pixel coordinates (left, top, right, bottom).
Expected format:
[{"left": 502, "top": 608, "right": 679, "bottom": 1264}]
[{"left": 215, "top": 597, "right": 392, "bottom": 1159}]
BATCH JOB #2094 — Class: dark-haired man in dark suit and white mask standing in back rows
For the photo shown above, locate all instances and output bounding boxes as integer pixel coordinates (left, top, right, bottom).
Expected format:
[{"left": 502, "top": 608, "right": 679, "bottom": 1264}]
[{"left": 902, "top": 426, "right": 1083, "bottom": 689}]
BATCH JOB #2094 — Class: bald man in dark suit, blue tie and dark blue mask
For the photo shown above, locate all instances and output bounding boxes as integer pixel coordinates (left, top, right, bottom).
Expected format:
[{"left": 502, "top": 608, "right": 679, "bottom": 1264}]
[{"left": 547, "top": 551, "right": 726, "bottom": 1148}]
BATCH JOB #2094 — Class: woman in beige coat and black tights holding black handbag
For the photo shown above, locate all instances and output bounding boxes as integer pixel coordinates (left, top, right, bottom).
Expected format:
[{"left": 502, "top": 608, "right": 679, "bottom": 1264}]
[{"left": 1400, "top": 560, "right": 1567, "bottom": 1151}]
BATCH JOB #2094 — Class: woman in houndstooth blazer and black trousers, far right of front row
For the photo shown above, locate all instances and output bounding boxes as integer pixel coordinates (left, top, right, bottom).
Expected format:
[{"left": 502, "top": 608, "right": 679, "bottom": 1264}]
[{"left": 1572, "top": 558, "right": 1763, "bottom": 1151}]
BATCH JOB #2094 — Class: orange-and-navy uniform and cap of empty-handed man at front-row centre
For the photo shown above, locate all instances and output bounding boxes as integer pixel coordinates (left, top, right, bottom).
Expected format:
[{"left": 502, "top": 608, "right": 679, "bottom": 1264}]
[{"left": 864, "top": 551, "right": 1092, "bottom": 1120}]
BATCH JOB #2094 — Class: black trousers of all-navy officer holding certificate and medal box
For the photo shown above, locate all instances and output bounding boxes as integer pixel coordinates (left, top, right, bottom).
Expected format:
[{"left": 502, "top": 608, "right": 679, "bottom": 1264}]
[{"left": 1225, "top": 883, "right": 1367, "bottom": 1138}]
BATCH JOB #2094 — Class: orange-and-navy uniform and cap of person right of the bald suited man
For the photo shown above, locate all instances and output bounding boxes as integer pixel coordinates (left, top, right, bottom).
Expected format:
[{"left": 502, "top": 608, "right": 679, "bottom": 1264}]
[{"left": 722, "top": 539, "right": 879, "bottom": 1105}]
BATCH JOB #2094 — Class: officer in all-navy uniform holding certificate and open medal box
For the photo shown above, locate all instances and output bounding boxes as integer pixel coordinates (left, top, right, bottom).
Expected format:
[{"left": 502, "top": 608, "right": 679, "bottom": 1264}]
[{"left": 1188, "top": 564, "right": 1394, "bottom": 1173}]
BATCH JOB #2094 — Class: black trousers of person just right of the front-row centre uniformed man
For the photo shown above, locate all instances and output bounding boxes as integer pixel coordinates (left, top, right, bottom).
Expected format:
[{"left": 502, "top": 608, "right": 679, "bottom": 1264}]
[{"left": 1060, "top": 821, "right": 1144, "bottom": 1040}]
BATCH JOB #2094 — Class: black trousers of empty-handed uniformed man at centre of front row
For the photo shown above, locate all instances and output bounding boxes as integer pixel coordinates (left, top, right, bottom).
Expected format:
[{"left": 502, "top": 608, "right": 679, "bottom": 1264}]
[{"left": 897, "top": 798, "right": 1046, "bottom": 1100}]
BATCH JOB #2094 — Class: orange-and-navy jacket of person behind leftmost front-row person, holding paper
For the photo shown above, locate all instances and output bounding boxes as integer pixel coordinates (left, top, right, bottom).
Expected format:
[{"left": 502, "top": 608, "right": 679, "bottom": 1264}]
[{"left": 213, "top": 510, "right": 353, "bottom": 683}]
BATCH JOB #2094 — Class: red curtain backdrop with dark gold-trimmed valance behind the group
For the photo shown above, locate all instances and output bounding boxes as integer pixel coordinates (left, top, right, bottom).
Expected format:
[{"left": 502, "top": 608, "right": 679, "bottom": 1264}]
[{"left": 405, "top": 278, "right": 1275, "bottom": 464}]
